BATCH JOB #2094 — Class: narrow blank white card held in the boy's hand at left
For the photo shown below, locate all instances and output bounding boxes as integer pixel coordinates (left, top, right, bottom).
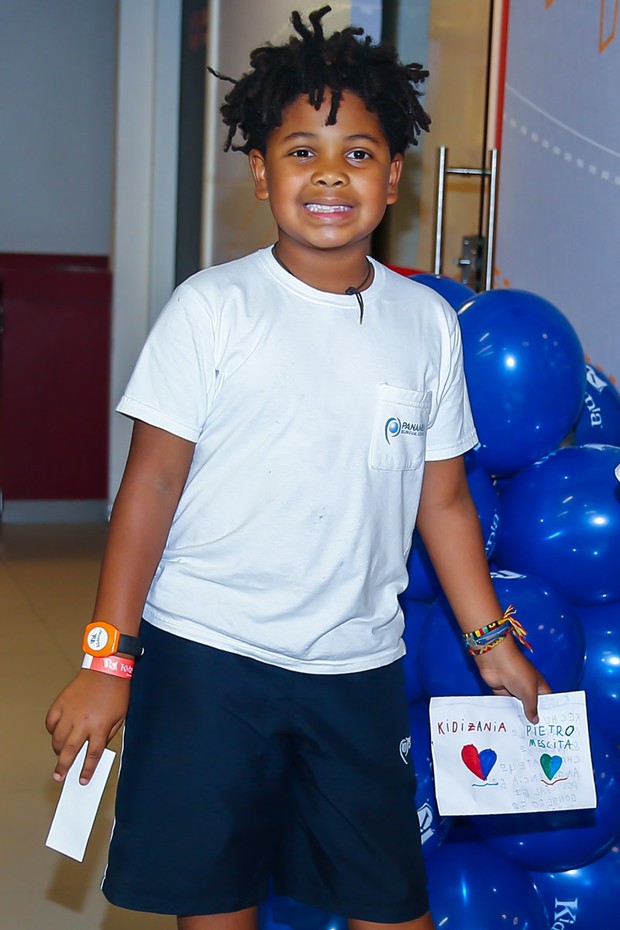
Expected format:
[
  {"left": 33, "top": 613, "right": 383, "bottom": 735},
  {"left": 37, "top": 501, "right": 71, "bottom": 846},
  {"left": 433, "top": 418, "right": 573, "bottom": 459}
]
[{"left": 45, "top": 743, "right": 116, "bottom": 862}]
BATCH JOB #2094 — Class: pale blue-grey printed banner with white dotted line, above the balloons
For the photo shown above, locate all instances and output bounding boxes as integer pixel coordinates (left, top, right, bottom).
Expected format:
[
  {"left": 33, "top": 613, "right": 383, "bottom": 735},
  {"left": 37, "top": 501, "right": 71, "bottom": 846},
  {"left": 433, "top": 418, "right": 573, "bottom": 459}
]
[{"left": 494, "top": 0, "right": 620, "bottom": 378}]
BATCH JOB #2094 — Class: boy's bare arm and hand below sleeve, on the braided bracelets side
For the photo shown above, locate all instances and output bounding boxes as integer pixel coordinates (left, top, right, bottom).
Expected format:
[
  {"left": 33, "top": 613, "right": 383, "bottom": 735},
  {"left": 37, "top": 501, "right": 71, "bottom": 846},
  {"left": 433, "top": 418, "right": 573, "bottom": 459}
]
[{"left": 417, "top": 456, "right": 551, "bottom": 723}]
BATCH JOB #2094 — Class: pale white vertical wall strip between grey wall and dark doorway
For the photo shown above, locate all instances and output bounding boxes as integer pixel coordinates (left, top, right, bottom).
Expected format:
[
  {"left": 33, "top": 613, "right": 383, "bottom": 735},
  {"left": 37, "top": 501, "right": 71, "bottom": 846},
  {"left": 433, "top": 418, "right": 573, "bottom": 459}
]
[{"left": 109, "top": 0, "right": 181, "bottom": 501}]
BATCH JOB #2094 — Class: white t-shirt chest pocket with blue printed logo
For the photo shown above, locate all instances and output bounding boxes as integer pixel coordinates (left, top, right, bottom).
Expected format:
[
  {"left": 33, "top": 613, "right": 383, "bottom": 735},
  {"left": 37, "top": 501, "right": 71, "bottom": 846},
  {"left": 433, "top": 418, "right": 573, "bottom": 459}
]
[{"left": 370, "top": 384, "right": 431, "bottom": 471}]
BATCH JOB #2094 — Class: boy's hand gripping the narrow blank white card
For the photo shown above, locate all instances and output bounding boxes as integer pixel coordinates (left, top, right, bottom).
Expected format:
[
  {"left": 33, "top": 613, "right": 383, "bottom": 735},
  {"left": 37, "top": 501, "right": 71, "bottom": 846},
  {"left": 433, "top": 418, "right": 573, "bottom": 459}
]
[{"left": 45, "top": 669, "right": 129, "bottom": 785}]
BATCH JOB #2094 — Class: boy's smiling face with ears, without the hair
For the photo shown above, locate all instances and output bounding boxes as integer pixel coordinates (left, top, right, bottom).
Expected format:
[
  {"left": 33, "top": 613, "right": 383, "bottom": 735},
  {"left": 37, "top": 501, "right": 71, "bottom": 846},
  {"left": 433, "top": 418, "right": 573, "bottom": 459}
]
[{"left": 250, "top": 92, "right": 402, "bottom": 254}]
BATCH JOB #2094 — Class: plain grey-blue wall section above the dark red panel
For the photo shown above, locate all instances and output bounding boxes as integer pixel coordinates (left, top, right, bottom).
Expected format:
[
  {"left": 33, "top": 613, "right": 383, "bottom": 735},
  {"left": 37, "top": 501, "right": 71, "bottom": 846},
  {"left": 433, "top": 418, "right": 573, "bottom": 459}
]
[{"left": 0, "top": 0, "right": 116, "bottom": 255}]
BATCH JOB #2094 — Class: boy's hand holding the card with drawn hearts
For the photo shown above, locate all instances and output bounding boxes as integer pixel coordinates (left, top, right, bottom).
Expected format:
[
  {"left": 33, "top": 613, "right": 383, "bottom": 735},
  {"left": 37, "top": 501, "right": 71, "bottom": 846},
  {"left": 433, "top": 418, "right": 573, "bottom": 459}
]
[{"left": 475, "top": 636, "right": 551, "bottom": 723}]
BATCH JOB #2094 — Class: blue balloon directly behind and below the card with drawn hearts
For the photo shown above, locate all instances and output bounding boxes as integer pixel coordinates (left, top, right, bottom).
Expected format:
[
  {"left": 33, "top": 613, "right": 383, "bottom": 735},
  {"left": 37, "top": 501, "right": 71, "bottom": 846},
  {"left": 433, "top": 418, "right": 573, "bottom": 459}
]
[{"left": 471, "top": 727, "right": 620, "bottom": 872}]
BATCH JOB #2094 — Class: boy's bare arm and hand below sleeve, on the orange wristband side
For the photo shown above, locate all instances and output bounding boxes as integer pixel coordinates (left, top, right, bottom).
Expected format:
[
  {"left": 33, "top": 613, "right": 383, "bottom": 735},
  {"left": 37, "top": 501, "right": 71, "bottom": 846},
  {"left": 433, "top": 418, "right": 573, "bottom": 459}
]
[{"left": 45, "top": 420, "right": 194, "bottom": 783}]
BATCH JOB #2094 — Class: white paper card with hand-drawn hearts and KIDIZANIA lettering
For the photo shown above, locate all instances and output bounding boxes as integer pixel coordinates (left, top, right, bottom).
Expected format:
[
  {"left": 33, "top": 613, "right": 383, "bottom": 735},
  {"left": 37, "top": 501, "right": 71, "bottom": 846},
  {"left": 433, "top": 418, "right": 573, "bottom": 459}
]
[{"left": 429, "top": 691, "right": 596, "bottom": 816}]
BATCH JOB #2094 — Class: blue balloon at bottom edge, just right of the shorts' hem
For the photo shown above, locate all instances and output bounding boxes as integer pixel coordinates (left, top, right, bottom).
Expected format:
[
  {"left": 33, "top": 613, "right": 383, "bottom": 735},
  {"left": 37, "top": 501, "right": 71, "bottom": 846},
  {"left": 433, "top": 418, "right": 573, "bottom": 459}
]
[{"left": 427, "top": 839, "right": 549, "bottom": 930}]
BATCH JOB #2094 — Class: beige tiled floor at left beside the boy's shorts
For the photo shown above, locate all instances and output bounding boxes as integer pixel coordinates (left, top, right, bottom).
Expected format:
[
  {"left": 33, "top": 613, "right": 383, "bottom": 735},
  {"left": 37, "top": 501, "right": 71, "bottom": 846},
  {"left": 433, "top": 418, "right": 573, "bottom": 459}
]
[{"left": 0, "top": 525, "right": 176, "bottom": 930}]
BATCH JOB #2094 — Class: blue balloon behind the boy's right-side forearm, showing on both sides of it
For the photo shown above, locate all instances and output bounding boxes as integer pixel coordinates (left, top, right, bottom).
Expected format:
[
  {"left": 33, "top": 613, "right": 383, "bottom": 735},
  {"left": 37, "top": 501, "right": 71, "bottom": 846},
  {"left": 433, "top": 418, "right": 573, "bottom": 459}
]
[{"left": 401, "top": 454, "right": 501, "bottom": 601}]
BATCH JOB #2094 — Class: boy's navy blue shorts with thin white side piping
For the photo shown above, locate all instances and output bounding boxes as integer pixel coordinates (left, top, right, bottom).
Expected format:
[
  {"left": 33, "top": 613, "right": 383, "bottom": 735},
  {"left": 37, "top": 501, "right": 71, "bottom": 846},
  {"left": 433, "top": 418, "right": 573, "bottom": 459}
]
[{"left": 103, "top": 623, "right": 428, "bottom": 923}]
